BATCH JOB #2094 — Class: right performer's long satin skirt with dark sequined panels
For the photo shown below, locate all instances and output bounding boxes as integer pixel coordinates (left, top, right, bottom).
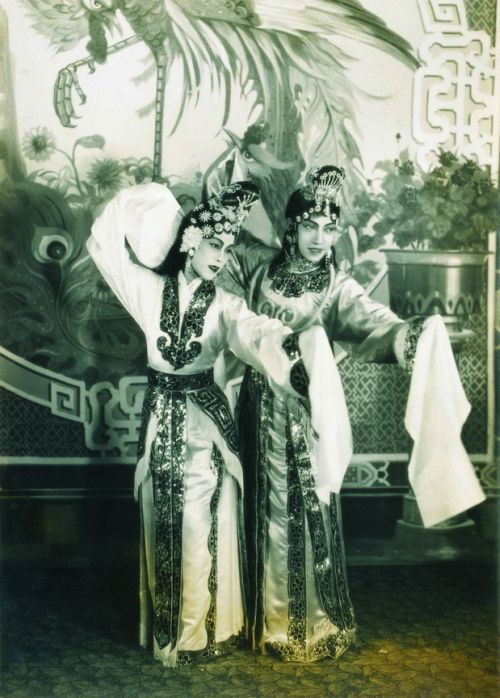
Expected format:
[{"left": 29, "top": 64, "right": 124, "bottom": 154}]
[{"left": 261, "top": 386, "right": 356, "bottom": 662}]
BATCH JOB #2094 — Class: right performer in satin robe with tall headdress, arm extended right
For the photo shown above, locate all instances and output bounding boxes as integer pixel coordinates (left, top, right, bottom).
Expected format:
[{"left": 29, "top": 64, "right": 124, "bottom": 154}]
[{"left": 220, "top": 166, "right": 484, "bottom": 662}]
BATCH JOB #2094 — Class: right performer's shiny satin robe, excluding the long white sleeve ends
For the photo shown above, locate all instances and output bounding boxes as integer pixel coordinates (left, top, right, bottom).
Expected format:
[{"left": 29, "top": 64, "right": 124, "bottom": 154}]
[{"left": 236, "top": 266, "right": 401, "bottom": 662}]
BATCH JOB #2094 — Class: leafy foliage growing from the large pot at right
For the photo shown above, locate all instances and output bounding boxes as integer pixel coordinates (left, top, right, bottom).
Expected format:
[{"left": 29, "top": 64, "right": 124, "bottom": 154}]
[{"left": 349, "top": 151, "right": 500, "bottom": 254}]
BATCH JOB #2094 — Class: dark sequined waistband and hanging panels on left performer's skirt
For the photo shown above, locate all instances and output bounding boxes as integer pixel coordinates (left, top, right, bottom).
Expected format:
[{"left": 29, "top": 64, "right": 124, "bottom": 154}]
[{"left": 140, "top": 369, "right": 241, "bottom": 652}]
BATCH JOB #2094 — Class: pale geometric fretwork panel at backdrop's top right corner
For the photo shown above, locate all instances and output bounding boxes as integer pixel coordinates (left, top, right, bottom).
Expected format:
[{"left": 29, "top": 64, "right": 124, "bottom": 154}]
[{"left": 412, "top": 0, "right": 498, "bottom": 169}]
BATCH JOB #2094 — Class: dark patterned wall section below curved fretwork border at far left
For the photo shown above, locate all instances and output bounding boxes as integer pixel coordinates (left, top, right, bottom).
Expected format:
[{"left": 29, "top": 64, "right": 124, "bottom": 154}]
[{"left": 0, "top": 388, "right": 90, "bottom": 458}]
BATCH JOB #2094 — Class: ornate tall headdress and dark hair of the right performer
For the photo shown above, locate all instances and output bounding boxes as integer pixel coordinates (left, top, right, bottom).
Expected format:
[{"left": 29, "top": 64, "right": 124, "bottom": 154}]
[{"left": 286, "top": 165, "right": 345, "bottom": 228}]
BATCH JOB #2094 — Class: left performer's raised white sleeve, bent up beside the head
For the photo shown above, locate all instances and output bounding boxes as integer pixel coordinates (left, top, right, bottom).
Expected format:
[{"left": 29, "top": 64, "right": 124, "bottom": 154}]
[{"left": 87, "top": 184, "right": 180, "bottom": 327}]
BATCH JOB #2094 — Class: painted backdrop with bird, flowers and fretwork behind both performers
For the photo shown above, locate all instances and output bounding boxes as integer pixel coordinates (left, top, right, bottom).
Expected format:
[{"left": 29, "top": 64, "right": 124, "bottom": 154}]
[{"left": 0, "top": 0, "right": 498, "bottom": 500}]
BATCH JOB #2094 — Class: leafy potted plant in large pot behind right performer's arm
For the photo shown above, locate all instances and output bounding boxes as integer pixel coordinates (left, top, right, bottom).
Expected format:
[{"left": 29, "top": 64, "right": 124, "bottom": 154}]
[{"left": 351, "top": 146, "right": 500, "bottom": 331}]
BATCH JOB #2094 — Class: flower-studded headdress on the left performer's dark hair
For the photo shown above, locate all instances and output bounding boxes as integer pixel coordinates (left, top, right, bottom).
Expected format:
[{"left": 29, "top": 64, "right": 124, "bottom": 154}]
[{"left": 180, "top": 181, "right": 259, "bottom": 252}]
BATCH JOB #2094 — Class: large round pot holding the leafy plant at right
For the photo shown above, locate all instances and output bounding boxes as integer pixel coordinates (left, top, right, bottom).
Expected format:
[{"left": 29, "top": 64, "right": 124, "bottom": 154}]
[{"left": 383, "top": 250, "right": 488, "bottom": 332}]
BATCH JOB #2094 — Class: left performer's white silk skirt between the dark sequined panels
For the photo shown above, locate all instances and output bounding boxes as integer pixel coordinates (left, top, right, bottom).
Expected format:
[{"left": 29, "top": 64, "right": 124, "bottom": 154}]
[{"left": 136, "top": 399, "right": 244, "bottom": 666}]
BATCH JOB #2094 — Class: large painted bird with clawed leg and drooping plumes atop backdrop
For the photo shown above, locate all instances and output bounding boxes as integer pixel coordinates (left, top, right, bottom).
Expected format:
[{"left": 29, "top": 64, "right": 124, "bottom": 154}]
[{"left": 23, "top": 0, "right": 417, "bottom": 190}]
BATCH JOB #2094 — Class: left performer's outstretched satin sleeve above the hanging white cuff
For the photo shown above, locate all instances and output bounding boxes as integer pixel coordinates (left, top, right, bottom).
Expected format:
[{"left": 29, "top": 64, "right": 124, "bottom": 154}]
[{"left": 218, "top": 289, "right": 296, "bottom": 395}]
